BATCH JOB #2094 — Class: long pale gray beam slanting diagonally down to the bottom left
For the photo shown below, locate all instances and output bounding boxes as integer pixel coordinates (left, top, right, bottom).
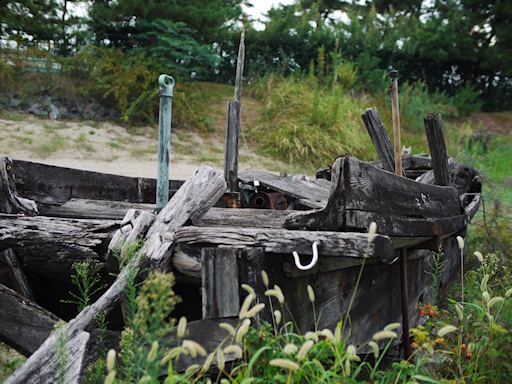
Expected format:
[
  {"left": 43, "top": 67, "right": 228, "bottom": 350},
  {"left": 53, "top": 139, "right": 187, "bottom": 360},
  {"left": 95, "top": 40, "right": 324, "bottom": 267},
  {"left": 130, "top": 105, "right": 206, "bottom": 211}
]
[{"left": 4, "top": 167, "right": 226, "bottom": 384}]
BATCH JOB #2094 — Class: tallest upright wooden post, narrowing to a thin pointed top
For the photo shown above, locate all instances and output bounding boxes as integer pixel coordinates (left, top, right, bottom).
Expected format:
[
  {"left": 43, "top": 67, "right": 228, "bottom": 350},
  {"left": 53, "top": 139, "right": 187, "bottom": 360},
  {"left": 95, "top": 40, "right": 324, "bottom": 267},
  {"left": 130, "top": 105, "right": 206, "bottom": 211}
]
[{"left": 224, "top": 31, "right": 245, "bottom": 192}]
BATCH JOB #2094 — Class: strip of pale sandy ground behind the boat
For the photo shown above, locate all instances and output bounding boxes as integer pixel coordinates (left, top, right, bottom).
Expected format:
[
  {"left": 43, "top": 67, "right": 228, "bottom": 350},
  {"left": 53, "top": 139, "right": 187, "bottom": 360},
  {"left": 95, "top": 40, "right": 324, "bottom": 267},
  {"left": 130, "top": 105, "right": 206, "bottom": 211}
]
[{"left": 0, "top": 115, "right": 296, "bottom": 179}]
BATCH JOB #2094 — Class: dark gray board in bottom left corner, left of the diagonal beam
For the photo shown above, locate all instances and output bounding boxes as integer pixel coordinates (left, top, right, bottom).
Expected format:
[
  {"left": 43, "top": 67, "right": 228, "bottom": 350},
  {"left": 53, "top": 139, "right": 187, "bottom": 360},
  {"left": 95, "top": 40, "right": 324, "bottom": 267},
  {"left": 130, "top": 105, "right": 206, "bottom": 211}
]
[{"left": 0, "top": 284, "right": 60, "bottom": 356}]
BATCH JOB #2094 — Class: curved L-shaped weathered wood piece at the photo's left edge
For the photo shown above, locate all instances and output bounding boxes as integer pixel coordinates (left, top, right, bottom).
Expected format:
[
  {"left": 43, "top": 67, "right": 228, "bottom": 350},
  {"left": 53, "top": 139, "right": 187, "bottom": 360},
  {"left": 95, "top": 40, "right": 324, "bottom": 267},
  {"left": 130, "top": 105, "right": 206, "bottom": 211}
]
[{"left": 0, "top": 156, "right": 37, "bottom": 216}]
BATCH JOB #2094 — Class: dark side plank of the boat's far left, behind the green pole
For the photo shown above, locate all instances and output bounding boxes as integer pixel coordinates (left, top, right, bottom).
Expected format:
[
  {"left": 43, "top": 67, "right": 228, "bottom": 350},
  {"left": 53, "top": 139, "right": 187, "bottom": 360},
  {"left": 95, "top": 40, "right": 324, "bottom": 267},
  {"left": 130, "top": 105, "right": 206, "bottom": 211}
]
[{"left": 12, "top": 160, "right": 183, "bottom": 204}]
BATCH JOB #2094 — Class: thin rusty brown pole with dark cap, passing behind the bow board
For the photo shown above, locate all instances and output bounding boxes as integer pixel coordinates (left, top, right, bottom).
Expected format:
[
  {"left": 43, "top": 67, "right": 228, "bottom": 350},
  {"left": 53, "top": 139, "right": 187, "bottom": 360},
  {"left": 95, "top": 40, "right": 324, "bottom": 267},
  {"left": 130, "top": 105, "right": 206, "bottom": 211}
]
[{"left": 389, "top": 69, "right": 412, "bottom": 359}]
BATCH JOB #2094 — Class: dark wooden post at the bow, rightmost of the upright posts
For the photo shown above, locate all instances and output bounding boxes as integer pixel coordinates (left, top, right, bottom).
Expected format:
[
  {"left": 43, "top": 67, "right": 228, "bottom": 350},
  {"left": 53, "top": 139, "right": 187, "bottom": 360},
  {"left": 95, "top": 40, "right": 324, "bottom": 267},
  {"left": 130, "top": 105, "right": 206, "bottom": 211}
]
[{"left": 424, "top": 113, "right": 450, "bottom": 185}]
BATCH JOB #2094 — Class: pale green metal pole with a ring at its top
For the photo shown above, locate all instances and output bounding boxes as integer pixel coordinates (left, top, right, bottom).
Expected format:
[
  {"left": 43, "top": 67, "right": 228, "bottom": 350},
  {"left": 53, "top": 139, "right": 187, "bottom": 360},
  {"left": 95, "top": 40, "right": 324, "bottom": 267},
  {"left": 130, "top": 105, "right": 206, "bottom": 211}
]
[{"left": 156, "top": 75, "right": 174, "bottom": 212}]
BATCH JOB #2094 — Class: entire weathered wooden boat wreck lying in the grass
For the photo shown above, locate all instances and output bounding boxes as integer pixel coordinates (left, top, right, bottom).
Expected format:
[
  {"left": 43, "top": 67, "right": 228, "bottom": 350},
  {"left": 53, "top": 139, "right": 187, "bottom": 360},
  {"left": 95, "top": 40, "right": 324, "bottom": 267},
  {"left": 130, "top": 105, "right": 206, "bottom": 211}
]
[{"left": 0, "top": 106, "right": 481, "bottom": 382}]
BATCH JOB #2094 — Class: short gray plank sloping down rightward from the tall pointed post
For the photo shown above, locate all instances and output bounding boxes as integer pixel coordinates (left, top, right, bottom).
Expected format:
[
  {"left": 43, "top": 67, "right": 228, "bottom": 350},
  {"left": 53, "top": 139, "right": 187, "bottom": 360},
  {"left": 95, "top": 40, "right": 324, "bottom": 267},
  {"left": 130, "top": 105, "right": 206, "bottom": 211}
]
[{"left": 238, "top": 171, "right": 329, "bottom": 208}]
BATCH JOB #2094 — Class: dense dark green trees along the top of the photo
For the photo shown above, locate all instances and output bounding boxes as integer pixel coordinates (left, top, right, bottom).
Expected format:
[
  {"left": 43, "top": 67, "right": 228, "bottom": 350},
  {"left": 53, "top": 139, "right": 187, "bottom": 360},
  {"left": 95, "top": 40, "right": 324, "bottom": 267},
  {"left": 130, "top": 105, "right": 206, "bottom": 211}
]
[{"left": 0, "top": 0, "right": 512, "bottom": 112}]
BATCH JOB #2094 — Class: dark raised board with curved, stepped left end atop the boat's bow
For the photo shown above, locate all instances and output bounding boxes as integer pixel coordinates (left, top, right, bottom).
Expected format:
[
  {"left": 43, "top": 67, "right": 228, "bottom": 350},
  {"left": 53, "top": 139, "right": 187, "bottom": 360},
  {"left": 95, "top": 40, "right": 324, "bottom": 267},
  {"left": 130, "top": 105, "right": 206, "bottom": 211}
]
[{"left": 284, "top": 157, "right": 462, "bottom": 236}]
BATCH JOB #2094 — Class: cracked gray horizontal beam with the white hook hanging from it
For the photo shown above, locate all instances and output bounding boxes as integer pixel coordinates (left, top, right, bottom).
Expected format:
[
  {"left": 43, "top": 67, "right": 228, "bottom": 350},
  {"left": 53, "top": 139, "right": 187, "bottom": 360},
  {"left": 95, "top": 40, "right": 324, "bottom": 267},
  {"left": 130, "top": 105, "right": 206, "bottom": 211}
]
[{"left": 172, "top": 226, "right": 394, "bottom": 261}]
